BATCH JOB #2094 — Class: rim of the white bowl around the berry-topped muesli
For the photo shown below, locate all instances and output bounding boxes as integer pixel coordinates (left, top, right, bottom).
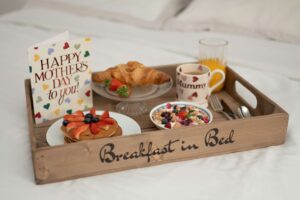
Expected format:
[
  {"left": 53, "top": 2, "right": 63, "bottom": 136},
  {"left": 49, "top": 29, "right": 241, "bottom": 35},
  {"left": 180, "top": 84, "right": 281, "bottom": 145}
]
[{"left": 149, "top": 101, "right": 213, "bottom": 130}]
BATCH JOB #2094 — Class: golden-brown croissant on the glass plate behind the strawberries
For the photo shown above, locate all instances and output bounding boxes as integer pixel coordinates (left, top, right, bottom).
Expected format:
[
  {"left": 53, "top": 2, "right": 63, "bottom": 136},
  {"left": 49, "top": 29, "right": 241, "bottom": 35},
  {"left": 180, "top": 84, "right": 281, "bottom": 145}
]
[{"left": 92, "top": 61, "right": 171, "bottom": 87}]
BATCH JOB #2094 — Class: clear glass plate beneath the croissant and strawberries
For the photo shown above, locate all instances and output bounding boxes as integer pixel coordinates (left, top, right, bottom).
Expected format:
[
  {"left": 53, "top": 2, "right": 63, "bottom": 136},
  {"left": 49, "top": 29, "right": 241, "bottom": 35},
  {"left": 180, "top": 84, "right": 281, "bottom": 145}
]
[{"left": 92, "top": 79, "right": 173, "bottom": 102}]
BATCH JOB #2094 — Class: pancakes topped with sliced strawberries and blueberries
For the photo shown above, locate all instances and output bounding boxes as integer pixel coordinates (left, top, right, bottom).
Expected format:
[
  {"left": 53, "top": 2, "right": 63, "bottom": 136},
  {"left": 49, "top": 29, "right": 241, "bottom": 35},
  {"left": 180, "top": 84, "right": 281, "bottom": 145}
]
[{"left": 61, "top": 108, "right": 122, "bottom": 143}]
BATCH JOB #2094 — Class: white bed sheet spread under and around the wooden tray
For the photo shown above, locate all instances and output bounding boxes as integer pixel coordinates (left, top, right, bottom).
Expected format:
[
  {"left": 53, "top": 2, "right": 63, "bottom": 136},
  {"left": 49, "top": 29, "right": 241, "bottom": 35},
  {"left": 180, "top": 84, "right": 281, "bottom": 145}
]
[{"left": 0, "top": 5, "right": 300, "bottom": 200}]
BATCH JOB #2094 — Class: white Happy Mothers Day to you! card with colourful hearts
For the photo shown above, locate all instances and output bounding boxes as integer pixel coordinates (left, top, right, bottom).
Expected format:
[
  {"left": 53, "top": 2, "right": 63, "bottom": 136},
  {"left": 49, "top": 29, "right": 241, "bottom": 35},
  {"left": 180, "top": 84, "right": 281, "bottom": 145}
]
[{"left": 28, "top": 33, "right": 93, "bottom": 124}]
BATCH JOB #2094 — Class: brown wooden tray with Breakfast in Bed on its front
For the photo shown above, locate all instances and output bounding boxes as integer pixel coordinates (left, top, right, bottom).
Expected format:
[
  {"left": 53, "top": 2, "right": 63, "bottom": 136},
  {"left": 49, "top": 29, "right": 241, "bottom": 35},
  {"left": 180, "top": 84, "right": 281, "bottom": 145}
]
[{"left": 25, "top": 65, "right": 288, "bottom": 184}]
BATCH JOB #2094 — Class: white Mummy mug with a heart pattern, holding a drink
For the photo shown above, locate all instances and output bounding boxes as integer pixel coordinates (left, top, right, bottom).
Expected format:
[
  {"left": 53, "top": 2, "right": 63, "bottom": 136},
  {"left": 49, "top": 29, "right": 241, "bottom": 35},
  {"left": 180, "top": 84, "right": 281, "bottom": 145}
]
[{"left": 176, "top": 64, "right": 225, "bottom": 107}]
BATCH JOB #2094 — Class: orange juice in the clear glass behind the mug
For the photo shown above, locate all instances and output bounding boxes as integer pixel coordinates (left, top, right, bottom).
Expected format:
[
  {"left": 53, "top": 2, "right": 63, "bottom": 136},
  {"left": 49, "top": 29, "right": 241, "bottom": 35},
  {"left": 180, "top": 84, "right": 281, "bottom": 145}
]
[{"left": 199, "top": 58, "right": 226, "bottom": 92}]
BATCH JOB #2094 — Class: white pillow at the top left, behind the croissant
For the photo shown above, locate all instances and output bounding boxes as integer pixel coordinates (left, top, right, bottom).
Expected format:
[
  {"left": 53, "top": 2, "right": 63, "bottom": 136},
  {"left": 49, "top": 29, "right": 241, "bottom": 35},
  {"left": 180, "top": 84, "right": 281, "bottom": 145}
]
[{"left": 27, "top": 0, "right": 190, "bottom": 28}]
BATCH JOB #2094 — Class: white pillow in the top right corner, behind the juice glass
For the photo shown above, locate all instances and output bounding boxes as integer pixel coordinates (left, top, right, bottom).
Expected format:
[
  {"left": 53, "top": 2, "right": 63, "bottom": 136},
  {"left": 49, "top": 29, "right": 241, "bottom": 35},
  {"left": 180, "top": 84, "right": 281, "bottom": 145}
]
[{"left": 165, "top": 0, "right": 300, "bottom": 43}]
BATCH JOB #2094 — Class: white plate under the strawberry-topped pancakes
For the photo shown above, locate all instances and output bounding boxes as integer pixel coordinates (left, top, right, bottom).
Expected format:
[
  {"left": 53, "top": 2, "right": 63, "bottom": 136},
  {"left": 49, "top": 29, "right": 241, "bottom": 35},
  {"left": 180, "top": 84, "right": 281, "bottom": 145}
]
[{"left": 46, "top": 110, "right": 142, "bottom": 146}]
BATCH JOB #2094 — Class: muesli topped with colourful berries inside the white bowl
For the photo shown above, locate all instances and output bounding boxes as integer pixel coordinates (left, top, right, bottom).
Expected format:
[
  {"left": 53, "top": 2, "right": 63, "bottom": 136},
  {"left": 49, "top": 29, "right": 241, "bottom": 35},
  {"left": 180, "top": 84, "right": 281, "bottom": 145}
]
[{"left": 151, "top": 103, "right": 210, "bottom": 129}]
